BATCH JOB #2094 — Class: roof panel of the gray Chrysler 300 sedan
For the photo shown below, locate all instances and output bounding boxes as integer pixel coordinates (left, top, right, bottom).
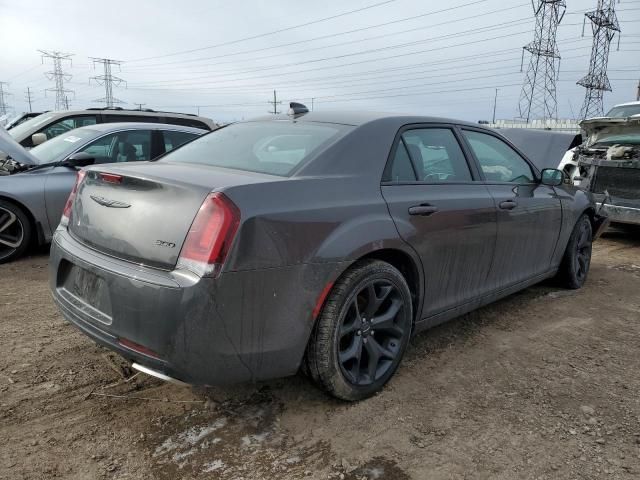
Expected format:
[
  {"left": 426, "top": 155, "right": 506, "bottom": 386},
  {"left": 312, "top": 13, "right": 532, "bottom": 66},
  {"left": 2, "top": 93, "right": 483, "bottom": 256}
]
[{"left": 247, "top": 111, "right": 482, "bottom": 128}]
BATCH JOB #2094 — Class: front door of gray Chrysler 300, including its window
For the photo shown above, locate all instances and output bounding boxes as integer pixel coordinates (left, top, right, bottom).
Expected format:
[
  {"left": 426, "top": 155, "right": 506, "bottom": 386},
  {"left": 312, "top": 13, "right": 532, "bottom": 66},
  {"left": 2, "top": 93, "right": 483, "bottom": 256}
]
[{"left": 462, "top": 128, "right": 562, "bottom": 287}]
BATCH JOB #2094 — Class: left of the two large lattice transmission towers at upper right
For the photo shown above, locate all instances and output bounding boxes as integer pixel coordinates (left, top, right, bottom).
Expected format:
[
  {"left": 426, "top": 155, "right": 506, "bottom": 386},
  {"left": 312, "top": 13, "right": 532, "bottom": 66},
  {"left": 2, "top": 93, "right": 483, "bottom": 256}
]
[{"left": 519, "top": 0, "right": 567, "bottom": 122}]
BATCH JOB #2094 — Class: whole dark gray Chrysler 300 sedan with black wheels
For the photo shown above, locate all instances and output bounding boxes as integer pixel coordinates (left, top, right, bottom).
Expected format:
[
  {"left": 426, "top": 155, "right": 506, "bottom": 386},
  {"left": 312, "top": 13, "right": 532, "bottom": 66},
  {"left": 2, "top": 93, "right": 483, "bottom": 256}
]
[{"left": 50, "top": 105, "right": 606, "bottom": 400}]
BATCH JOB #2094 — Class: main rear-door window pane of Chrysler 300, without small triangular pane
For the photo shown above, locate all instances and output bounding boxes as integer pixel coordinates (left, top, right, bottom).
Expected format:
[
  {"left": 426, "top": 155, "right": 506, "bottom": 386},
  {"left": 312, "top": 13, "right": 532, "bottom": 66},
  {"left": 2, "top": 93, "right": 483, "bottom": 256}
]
[{"left": 402, "top": 128, "right": 472, "bottom": 183}]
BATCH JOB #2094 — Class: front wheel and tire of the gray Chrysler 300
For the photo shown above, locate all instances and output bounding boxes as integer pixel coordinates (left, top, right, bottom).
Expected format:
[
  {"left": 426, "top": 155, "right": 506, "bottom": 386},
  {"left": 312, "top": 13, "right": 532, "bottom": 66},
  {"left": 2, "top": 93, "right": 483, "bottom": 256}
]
[{"left": 558, "top": 214, "right": 593, "bottom": 289}]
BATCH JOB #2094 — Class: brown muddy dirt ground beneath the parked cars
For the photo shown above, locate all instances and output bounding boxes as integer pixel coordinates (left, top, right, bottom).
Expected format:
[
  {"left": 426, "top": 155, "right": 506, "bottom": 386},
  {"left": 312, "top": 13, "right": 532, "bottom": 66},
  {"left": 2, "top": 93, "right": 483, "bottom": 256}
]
[{"left": 0, "top": 234, "right": 640, "bottom": 480}]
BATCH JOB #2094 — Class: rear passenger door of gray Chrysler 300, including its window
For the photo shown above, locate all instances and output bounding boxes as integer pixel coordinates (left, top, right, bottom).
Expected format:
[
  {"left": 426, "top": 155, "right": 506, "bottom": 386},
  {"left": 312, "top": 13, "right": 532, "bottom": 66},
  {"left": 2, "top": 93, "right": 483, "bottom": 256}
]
[{"left": 382, "top": 124, "right": 497, "bottom": 317}]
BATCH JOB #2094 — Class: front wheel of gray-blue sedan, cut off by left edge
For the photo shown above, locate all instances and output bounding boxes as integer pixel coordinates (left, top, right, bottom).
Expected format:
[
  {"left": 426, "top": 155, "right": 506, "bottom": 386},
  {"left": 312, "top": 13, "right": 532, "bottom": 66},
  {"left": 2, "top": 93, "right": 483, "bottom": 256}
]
[{"left": 0, "top": 200, "right": 32, "bottom": 263}]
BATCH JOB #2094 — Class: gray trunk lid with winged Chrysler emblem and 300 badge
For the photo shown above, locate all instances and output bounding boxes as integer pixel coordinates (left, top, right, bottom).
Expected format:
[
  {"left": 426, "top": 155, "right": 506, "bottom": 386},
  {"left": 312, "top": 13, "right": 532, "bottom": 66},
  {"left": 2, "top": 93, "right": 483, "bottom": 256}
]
[{"left": 68, "top": 162, "right": 271, "bottom": 269}]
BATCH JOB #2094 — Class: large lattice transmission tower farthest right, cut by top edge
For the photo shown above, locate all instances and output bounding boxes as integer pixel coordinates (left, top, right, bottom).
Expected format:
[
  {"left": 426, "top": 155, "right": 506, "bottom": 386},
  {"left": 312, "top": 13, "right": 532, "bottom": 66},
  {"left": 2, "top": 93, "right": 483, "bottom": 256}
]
[{"left": 577, "top": 0, "right": 620, "bottom": 119}]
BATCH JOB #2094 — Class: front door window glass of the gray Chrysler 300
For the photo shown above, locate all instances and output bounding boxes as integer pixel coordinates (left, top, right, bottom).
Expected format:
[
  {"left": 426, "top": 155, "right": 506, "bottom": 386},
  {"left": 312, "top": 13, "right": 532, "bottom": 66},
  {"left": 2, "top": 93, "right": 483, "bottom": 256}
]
[{"left": 463, "top": 130, "right": 534, "bottom": 183}]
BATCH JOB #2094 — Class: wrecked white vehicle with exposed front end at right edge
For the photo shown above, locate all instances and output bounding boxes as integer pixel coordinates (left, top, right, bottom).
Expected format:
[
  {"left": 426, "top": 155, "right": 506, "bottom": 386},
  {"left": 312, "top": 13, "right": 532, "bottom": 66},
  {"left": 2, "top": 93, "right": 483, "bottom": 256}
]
[{"left": 574, "top": 116, "right": 640, "bottom": 225}]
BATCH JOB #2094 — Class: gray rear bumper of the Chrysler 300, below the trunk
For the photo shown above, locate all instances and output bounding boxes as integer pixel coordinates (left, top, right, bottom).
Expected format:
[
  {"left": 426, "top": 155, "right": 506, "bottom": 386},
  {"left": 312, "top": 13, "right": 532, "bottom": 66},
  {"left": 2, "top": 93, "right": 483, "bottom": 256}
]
[{"left": 49, "top": 229, "right": 336, "bottom": 385}]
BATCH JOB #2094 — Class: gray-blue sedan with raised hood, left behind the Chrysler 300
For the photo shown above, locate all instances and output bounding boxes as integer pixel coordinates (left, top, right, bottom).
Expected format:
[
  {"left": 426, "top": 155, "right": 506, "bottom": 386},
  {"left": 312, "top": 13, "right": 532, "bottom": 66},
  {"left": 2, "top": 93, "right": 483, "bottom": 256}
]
[{"left": 0, "top": 123, "right": 206, "bottom": 263}]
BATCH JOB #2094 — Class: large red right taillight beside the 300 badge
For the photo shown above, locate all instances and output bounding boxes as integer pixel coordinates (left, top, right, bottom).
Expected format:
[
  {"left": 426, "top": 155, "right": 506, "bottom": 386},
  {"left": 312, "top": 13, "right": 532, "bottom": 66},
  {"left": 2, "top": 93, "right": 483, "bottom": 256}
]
[{"left": 177, "top": 193, "right": 240, "bottom": 277}]
